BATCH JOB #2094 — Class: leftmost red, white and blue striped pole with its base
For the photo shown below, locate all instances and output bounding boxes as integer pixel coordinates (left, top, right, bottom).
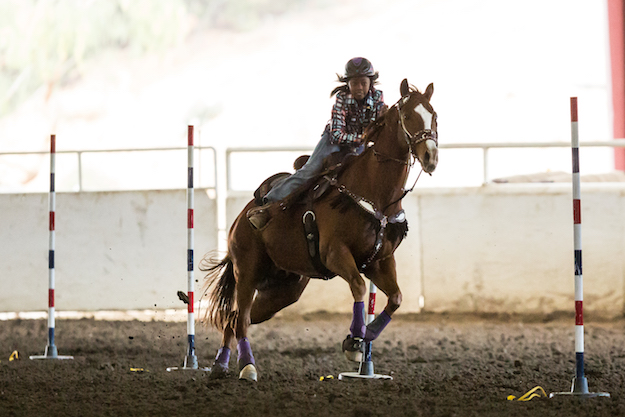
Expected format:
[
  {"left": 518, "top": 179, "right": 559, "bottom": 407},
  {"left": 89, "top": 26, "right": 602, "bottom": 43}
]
[{"left": 30, "top": 135, "right": 74, "bottom": 359}]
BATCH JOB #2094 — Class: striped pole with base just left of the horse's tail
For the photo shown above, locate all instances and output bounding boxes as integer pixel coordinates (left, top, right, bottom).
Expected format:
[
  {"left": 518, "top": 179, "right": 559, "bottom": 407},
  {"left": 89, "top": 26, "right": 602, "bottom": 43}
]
[{"left": 167, "top": 125, "right": 209, "bottom": 371}]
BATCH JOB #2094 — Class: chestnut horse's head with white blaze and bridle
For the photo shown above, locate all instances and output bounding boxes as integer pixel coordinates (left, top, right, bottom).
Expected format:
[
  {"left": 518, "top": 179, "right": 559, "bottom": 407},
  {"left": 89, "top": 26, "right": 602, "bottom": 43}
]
[{"left": 396, "top": 78, "right": 438, "bottom": 174}]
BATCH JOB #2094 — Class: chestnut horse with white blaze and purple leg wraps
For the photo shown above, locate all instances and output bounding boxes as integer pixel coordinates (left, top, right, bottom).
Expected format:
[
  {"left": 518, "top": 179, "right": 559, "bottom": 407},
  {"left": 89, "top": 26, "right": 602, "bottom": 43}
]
[{"left": 202, "top": 79, "right": 438, "bottom": 381}]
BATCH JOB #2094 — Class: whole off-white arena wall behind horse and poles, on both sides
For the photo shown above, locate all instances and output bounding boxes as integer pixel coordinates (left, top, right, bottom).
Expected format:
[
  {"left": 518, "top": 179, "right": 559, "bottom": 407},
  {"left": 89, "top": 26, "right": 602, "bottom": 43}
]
[{"left": 0, "top": 184, "right": 625, "bottom": 316}]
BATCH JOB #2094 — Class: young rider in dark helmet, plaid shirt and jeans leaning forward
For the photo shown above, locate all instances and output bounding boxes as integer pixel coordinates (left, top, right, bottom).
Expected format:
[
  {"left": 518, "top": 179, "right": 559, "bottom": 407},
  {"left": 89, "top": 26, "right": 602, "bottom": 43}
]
[{"left": 247, "top": 57, "right": 387, "bottom": 229}]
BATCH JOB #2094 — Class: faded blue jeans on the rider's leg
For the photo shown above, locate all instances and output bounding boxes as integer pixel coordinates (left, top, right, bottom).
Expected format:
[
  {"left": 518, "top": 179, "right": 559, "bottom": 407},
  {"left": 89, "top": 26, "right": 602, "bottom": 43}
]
[{"left": 265, "top": 127, "right": 363, "bottom": 203}]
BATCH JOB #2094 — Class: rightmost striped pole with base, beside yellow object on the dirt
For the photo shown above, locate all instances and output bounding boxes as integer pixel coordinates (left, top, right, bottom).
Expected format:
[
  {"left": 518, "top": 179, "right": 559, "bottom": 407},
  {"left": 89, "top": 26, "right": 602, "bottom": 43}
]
[{"left": 550, "top": 97, "right": 610, "bottom": 397}]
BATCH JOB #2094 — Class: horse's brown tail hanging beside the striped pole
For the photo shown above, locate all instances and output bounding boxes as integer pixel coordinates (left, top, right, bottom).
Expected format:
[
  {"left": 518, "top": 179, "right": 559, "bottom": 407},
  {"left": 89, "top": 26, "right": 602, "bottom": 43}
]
[{"left": 199, "top": 255, "right": 236, "bottom": 331}]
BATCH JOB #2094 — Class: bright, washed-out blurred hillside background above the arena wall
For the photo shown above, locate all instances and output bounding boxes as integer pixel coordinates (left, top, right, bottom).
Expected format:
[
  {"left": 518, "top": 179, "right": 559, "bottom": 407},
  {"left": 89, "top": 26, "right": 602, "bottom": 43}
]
[{"left": 0, "top": 0, "right": 614, "bottom": 192}]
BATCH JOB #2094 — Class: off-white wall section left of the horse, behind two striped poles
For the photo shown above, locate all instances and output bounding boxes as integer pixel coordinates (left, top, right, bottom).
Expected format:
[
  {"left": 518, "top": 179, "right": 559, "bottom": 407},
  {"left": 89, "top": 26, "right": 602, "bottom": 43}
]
[{"left": 0, "top": 190, "right": 217, "bottom": 311}]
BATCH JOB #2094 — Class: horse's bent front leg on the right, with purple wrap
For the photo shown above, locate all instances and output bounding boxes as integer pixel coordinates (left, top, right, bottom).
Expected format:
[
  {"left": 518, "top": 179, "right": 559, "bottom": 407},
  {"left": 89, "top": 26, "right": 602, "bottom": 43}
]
[{"left": 364, "top": 256, "right": 402, "bottom": 342}]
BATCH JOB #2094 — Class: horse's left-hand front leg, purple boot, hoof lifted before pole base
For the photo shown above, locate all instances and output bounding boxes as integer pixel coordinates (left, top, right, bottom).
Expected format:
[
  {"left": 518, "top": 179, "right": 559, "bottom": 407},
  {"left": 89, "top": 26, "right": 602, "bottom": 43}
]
[{"left": 325, "top": 246, "right": 367, "bottom": 362}]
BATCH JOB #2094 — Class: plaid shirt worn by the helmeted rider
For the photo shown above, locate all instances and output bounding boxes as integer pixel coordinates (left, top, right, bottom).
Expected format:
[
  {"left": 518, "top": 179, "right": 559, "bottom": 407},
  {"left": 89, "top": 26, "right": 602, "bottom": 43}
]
[{"left": 330, "top": 88, "right": 384, "bottom": 145}]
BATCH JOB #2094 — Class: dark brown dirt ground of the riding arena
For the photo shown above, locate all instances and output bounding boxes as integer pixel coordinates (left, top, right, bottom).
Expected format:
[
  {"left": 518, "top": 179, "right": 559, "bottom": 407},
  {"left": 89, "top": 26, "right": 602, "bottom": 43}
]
[{"left": 0, "top": 313, "right": 625, "bottom": 417}]
